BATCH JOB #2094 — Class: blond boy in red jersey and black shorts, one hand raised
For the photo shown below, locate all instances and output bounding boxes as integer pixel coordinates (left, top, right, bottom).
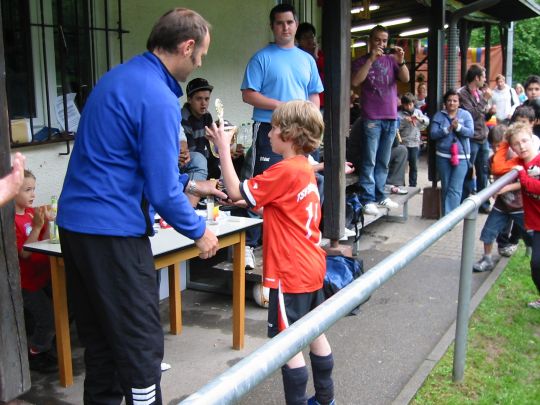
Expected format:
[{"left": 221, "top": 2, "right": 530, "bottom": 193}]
[{"left": 207, "top": 100, "right": 334, "bottom": 404}]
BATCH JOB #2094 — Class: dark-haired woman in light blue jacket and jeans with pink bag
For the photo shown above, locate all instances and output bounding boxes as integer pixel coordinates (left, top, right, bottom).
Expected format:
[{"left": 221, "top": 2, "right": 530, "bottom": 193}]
[{"left": 429, "top": 89, "right": 474, "bottom": 215}]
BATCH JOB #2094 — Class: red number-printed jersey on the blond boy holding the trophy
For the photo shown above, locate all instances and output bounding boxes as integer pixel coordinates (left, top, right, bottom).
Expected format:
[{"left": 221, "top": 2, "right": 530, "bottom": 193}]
[{"left": 241, "top": 155, "right": 326, "bottom": 293}]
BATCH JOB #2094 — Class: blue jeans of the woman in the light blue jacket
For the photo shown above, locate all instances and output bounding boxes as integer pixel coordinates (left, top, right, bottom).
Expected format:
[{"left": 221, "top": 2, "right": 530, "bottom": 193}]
[{"left": 436, "top": 155, "right": 467, "bottom": 215}]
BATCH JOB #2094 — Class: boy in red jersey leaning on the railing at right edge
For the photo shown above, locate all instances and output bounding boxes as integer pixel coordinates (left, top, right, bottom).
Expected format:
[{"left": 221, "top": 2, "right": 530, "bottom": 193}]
[{"left": 497, "top": 123, "right": 540, "bottom": 309}]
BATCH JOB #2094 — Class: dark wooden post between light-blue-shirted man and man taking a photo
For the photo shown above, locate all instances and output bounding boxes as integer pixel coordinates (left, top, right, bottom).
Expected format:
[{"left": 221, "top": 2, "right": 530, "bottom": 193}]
[{"left": 322, "top": 0, "right": 351, "bottom": 247}]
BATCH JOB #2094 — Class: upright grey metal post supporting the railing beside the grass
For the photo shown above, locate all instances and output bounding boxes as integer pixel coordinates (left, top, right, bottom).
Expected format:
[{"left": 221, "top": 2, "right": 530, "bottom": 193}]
[{"left": 452, "top": 206, "right": 478, "bottom": 382}]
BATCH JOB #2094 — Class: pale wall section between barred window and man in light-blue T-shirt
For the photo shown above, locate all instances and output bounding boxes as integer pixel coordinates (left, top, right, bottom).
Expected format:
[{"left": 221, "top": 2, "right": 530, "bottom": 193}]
[{"left": 123, "top": 0, "right": 276, "bottom": 124}]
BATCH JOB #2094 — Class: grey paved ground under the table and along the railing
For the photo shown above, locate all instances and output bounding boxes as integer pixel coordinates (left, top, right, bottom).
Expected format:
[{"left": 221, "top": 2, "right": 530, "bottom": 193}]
[{"left": 12, "top": 155, "right": 505, "bottom": 405}]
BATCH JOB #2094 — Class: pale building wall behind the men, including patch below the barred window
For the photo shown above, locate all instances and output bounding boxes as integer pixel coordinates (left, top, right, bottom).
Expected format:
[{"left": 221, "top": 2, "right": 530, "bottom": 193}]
[{"left": 18, "top": 0, "right": 276, "bottom": 205}]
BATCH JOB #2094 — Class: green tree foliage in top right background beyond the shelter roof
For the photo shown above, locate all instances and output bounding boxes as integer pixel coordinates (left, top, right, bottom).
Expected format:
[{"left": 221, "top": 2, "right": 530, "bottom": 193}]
[{"left": 470, "top": 17, "right": 540, "bottom": 84}]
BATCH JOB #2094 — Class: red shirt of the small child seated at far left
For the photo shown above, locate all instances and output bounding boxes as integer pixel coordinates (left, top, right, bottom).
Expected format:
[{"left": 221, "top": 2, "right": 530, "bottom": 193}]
[{"left": 15, "top": 208, "right": 51, "bottom": 291}]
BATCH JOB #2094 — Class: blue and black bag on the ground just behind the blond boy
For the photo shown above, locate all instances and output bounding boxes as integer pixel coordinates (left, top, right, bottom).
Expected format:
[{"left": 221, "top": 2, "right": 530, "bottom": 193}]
[{"left": 323, "top": 255, "right": 370, "bottom": 315}]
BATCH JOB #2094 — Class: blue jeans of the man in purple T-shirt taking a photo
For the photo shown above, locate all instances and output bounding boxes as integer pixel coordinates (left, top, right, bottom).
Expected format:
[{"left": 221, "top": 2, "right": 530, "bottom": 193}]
[{"left": 358, "top": 120, "right": 397, "bottom": 204}]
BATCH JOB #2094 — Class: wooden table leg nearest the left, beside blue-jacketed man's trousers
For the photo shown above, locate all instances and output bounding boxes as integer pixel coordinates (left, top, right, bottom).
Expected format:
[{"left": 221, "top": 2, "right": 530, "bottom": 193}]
[{"left": 50, "top": 256, "right": 73, "bottom": 387}]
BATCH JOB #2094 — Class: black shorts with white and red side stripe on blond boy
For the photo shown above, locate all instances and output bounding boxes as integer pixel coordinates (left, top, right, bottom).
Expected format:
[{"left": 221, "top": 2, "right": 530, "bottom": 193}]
[{"left": 268, "top": 288, "right": 325, "bottom": 338}]
